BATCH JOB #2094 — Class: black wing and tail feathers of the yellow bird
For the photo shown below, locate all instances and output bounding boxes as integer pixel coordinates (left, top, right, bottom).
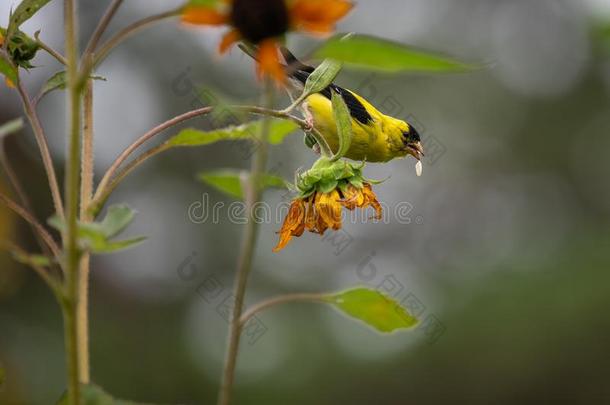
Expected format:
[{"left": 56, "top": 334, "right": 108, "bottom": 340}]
[{"left": 281, "top": 47, "right": 373, "bottom": 124}]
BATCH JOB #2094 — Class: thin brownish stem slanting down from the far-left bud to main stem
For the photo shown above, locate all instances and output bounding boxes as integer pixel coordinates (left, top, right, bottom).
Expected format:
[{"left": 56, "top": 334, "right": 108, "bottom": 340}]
[{"left": 17, "top": 80, "right": 64, "bottom": 218}]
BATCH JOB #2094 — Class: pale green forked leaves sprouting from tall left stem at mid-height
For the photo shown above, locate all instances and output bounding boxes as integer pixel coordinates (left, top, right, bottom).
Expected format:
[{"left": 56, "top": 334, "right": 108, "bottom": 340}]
[{"left": 47, "top": 205, "right": 146, "bottom": 253}]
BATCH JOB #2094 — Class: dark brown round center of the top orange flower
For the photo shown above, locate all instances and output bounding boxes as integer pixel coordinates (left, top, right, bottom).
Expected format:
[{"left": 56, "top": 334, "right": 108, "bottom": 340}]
[{"left": 231, "top": 0, "right": 289, "bottom": 44}]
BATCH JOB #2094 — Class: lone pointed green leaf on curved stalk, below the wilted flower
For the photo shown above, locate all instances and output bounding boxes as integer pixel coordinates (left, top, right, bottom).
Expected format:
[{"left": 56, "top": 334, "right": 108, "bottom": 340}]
[{"left": 330, "top": 288, "right": 418, "bottom": 333}]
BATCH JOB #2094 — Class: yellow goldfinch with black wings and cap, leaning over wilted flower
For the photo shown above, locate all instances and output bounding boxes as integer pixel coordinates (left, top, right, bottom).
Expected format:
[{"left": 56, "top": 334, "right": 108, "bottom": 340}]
[{"left": 281, "top": 48, "right": 423, "bottom": 162}]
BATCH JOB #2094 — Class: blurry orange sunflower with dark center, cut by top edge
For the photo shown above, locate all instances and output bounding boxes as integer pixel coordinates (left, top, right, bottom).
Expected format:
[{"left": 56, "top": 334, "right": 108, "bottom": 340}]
[{"left": 182, "top": 0, "right": 353, "bottom": 83}]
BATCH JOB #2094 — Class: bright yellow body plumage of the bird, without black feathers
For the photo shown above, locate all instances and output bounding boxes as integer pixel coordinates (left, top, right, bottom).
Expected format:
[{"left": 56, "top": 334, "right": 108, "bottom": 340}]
[{"left": 305, "top": 93, "right": 408, "bottom": 162}]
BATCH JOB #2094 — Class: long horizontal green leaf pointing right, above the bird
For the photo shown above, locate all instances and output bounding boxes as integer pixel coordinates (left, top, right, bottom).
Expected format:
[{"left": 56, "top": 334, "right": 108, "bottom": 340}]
[{"left": 314, "top": 35, "right": 474, "bottom": 73}]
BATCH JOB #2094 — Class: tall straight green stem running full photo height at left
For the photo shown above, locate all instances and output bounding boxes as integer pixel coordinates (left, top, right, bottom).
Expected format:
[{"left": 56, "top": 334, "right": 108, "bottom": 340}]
[{"left": 63, "top": 0, "right": 82, "bottom": 405}]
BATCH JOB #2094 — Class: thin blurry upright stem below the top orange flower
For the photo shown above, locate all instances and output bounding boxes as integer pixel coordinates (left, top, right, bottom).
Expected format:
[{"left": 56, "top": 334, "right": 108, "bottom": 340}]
[{"left": 218, "top": 80, "right": 273, "bottom": 405}]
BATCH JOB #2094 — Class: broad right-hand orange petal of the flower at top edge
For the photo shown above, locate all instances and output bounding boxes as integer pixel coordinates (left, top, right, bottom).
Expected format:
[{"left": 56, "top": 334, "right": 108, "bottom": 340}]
[{"left": 290, "top": 0, "right": 354, "bottom": 34}]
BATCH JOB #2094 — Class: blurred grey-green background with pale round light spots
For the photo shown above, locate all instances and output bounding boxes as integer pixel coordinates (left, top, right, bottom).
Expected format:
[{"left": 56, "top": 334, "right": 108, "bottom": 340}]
[{"left": 0, "top": 0, "right": 610, "bottom": 404}]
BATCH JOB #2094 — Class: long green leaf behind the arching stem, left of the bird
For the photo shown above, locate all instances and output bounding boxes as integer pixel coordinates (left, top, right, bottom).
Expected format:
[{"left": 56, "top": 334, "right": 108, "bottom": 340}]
[{"left": 167, "top": 119, "right": 298, "bottom": 147}]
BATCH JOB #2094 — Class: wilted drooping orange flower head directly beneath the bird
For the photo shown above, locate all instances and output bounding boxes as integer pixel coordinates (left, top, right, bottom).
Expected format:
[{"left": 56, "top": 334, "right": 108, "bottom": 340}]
[{"left": 273, "top": 158, "right": 382, "bottom": 252}]
